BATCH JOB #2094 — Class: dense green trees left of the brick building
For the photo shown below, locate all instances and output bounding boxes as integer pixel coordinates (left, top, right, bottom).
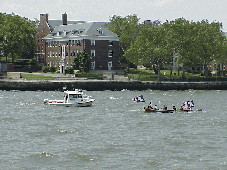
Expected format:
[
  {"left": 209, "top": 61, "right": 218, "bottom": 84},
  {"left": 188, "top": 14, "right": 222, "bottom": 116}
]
[{"left": 0, "top": 13, "right": 36, "bottom": 62}]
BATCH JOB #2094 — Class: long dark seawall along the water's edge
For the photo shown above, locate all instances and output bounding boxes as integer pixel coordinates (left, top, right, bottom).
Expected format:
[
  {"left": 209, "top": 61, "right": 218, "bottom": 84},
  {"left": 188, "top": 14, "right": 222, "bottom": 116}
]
[{"left": 0, "top": 80, "right": 227, "bottom": 91}]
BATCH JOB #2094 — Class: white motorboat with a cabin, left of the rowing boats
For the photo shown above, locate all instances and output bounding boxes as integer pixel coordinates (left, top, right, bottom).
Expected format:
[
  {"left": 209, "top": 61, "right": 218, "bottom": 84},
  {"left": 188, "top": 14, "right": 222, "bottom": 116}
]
[{"left": 43, "top": 89, "right": 95, "bottom": 107}]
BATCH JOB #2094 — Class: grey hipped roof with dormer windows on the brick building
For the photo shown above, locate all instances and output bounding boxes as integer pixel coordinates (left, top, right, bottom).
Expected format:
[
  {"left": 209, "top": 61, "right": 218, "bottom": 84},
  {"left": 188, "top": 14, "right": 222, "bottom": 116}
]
[{"left": 44, "top": 22, "right": 119, "bottom": 41}]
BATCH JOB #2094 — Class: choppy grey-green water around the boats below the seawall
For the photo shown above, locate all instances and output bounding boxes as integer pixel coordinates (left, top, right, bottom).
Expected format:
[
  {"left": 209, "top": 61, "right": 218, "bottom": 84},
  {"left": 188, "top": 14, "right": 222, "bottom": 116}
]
[{"left": 0, "top": 90, "right": 227, "bottom": 169}]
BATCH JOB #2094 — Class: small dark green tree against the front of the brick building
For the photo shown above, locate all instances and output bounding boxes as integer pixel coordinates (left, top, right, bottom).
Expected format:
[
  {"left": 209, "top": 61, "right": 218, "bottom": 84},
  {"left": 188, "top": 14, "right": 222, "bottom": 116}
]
[{"left": 73, "top": 50, "right": 91, "bottom": 72}]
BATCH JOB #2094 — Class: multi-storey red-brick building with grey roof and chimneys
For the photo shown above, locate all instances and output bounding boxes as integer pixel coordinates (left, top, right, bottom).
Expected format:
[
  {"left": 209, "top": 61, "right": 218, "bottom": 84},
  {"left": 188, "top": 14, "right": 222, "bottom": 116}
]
[{"left": 36, "top": 13, "right": 119, "bottom": 70}]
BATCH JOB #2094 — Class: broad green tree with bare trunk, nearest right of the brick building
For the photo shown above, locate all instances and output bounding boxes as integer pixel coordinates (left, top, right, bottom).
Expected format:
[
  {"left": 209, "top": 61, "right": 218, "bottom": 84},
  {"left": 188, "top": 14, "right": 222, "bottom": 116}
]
[{"left": 125, "top": 26, "right": 173, "bottom": 79}]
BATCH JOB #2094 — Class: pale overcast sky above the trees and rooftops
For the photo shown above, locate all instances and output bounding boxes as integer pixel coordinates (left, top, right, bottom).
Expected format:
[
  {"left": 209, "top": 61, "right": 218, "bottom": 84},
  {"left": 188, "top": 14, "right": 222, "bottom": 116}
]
[{"left": 0, "top": 0, "right": 227, "bottom": 31}]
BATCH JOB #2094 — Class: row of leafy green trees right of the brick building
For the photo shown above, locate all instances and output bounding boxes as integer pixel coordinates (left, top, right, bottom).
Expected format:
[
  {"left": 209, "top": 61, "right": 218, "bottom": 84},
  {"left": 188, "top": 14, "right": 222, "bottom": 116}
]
[{"left": 106, "top": 15, "right": 227, "bottom": 76}]
